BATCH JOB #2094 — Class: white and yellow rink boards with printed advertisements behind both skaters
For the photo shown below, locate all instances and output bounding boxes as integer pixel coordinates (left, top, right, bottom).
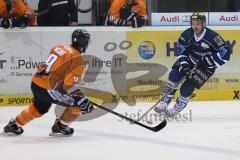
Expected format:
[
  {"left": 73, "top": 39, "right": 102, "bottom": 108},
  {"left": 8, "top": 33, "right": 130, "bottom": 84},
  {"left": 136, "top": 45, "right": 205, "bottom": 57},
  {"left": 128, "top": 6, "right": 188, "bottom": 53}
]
[{"left": 0, "top": 26, "right": 240, "bottom": 106}]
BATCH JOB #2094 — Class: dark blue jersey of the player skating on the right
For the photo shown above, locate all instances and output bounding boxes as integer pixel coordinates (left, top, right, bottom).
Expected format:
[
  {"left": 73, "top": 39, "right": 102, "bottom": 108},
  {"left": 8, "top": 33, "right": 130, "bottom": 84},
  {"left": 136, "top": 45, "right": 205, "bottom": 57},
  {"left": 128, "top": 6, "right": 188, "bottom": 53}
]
[{"left": 178, "top": 28, "right": 231, "bottom": 68}]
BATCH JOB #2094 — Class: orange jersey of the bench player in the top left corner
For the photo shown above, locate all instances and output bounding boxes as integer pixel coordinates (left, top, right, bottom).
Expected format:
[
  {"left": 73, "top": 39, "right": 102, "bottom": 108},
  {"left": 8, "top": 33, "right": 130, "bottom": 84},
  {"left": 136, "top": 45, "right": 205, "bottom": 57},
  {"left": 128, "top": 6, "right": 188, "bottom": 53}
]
[{"left": 0, "top": 0, "right": 37, "bottom": 26}]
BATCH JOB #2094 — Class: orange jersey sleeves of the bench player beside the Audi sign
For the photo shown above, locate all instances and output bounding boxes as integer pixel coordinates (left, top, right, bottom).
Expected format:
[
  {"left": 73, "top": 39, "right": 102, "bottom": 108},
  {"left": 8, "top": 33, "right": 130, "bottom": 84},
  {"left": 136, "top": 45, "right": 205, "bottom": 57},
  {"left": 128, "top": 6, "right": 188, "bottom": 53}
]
[{"left": 109, "top": 0, "right": 147, "bottom": 22}]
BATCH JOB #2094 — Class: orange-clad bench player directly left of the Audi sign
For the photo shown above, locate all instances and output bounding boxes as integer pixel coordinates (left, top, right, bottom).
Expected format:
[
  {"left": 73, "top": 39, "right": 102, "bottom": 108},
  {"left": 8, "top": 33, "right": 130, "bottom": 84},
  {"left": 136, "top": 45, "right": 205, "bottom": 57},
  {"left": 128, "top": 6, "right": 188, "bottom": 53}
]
[{"left": 105, "top": 0, "right": 147, "bottom": 28}]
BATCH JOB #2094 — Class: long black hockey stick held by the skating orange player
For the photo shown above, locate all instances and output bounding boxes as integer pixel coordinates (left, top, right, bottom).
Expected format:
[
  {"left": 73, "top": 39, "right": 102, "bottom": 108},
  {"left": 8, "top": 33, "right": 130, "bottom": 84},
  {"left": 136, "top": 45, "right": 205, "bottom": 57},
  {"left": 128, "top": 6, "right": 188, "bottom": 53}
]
[{"left": 91, "top": 102, "right": 167, "bottom": 132}]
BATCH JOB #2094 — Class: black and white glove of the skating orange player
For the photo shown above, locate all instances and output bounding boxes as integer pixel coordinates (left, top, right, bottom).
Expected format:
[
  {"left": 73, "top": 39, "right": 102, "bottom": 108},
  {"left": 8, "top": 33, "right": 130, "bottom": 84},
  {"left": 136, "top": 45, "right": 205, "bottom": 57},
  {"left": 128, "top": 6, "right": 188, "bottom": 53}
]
[{"left": 73, "top": 96, "right": 94, "bottom": 114}]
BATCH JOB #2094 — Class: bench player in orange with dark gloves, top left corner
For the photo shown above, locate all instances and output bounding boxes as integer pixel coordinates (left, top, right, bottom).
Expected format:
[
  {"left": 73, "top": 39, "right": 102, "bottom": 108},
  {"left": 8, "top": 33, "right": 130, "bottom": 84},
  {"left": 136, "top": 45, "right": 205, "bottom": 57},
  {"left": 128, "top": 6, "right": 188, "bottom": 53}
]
[{"left": 0, "top": 0, "right": 36, "bottom": 28}]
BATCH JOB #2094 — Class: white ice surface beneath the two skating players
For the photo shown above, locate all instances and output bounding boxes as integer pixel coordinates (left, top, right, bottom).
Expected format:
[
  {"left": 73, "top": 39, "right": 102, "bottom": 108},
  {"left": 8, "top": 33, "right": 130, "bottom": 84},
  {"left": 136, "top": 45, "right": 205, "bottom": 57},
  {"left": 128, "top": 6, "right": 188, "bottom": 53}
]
[{"left": 0, "top": 101, "right": 240, "bottom": 160}]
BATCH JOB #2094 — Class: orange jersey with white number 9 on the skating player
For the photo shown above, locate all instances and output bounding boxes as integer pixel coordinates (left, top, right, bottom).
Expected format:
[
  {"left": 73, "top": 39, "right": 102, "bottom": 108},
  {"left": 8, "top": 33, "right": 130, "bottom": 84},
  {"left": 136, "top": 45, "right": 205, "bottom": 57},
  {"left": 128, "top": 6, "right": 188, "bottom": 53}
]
[{"left": 32, "top": 45, "right": 85, "bottom": 91}]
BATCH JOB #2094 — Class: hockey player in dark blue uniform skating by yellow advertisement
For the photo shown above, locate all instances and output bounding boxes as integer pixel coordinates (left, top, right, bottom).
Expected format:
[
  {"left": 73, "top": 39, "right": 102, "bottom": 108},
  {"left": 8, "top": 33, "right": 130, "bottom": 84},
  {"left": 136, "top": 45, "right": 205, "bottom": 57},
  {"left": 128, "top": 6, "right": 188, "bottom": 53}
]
[{"left": 154, "top": 12, "right": 231, "bottom": 117}]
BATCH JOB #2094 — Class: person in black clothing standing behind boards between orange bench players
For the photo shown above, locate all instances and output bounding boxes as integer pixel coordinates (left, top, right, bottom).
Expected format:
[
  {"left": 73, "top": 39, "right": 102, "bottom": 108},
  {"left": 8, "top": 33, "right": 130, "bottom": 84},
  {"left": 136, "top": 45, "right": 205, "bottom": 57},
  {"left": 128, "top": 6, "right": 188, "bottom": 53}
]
[{"left": 38, "top": 0, "right": 78, "bottom": 26}]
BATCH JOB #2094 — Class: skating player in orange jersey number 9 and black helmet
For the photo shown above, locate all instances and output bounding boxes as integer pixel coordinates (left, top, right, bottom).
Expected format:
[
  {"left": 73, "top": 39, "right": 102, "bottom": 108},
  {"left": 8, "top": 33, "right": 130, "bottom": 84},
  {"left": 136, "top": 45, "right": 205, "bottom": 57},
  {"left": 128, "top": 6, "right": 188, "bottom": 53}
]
[{"left": 4, "top": 29, "right": 93, "bottom": 135}]
